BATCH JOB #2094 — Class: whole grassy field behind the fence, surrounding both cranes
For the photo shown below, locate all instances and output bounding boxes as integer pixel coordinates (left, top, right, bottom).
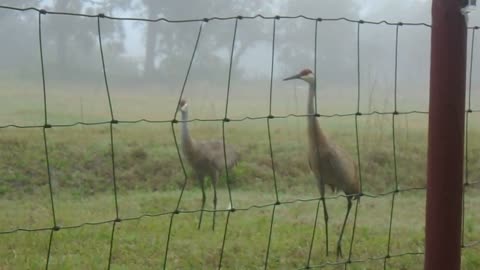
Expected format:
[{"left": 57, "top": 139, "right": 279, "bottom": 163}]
[{"left": 0, "top": 83, "right": 480, "bottom": 269}]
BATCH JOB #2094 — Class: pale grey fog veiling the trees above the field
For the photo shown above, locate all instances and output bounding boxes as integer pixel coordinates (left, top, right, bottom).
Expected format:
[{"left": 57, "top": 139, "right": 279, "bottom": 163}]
[{"left": 0, "top": 0, "right": 480, "bottom": 121}]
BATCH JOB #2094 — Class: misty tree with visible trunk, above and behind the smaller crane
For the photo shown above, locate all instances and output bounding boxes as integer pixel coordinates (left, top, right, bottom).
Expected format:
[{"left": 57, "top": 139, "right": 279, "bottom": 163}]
[{"left": 142, "top": 0, "right": 269, "bottom": 81}]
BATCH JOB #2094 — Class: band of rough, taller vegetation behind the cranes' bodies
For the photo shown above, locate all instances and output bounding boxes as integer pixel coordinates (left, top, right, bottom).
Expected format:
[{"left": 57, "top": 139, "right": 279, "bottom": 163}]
[{"left": 0, "top": 116, "right": 480, "bottom": 196}]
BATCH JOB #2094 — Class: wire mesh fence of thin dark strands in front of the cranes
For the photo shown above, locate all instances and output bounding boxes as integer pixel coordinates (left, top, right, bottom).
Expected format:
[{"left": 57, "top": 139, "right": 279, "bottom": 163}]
[{"left": 0, "top": 5, "right": 480, "bottom": 269}]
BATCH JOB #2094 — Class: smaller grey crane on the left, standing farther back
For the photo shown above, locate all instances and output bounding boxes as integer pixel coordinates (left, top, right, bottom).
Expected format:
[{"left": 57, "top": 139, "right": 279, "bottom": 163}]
[{"left": 178, "top": 99, "right": 239, "bottom": 229}]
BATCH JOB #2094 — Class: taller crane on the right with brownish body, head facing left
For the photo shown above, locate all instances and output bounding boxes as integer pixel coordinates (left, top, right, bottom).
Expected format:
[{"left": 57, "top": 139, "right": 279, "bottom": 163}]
[{"left": 284, "top": 69, "right": 360, "bottom": 258}]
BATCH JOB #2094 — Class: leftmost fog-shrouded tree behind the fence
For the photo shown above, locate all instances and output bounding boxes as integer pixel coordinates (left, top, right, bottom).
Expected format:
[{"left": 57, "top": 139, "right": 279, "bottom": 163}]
[{"left": 42, "top": 0, "right": 130, "bottom": 79}]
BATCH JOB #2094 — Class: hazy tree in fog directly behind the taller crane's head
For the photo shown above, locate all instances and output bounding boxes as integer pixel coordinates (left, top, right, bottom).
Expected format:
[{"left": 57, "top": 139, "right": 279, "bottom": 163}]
[{"left": 278, "top": 0, "right": 359, "bottom": 84}]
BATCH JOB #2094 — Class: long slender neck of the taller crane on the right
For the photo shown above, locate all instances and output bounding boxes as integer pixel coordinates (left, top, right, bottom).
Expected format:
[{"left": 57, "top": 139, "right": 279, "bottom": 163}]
[{"left": 307, "top": 82, "right": 327, "bottom": 152}]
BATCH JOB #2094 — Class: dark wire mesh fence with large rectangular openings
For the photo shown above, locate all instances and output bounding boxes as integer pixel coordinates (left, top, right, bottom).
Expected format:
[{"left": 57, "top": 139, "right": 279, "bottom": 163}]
[{"left": 0, "top": 6, "right": 480, "bottom": 269}]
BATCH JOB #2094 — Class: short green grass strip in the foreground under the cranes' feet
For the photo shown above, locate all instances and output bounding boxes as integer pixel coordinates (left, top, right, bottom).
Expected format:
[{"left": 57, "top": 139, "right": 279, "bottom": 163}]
[{"left": 0, "top": 189, "right": 480, "bottom": 269}]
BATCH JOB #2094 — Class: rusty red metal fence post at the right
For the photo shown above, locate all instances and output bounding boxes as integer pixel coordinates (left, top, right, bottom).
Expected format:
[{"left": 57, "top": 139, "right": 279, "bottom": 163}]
[{"left": 424, "top": 0, "right": 467, "bottom": 270}]
